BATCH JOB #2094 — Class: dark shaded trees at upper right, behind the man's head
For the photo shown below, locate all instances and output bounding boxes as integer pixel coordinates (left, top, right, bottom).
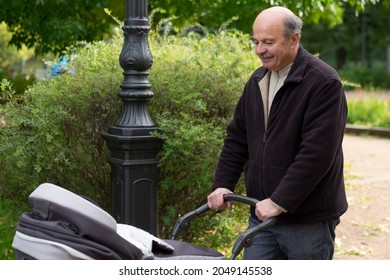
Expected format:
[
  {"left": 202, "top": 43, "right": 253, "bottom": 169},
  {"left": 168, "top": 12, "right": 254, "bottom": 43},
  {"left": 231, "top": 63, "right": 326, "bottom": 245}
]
[{"left": 302, "top": 1, "right": 390, "bottom": 70}]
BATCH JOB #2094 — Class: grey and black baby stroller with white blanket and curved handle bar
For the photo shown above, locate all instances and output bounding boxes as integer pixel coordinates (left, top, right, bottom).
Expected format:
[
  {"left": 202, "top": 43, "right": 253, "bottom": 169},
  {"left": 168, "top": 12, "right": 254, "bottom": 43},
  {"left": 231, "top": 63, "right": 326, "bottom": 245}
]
[{"left": 12, "top": 183, "right": 275, "bottom": 260}]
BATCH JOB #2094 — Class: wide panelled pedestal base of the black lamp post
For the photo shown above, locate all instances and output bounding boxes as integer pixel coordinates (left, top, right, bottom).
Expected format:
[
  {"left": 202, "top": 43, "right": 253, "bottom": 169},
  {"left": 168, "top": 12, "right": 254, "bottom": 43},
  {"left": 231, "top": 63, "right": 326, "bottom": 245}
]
[{"left": 102, "top": 127, "right": 162, "bottom": 235}]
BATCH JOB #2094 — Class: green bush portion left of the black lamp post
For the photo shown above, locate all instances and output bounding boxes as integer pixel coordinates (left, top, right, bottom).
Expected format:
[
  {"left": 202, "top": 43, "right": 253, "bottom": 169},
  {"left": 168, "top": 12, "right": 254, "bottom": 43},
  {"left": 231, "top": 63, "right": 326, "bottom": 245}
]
[{"left": 0, "top": 37, "right": 121, "bottom": 207}]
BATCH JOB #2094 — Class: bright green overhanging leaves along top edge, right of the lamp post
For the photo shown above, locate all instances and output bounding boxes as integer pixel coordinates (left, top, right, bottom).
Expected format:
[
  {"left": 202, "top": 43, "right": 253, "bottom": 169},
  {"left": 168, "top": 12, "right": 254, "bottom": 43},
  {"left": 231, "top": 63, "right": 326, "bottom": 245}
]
[{"left": 150, "top": 0, "right": 378, "bottom": 33}]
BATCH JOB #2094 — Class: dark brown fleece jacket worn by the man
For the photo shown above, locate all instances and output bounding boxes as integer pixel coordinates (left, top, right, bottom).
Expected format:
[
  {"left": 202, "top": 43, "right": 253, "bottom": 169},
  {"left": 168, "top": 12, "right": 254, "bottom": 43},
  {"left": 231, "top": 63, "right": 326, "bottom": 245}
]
[{"left": 212, "top": 46, "right": 348, "bottom": 222}]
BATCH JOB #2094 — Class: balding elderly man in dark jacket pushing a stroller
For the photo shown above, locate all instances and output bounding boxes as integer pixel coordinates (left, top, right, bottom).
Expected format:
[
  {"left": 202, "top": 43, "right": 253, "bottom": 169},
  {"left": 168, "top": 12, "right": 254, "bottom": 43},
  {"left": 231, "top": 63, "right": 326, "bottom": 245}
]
[{"left": 208, "top": 7, "right": 348, "bottom": 260}]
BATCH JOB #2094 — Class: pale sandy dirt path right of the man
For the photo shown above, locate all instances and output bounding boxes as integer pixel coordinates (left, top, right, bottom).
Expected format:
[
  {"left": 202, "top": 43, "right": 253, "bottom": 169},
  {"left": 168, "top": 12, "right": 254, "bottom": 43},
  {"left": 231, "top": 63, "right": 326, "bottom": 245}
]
[{"left": 334, "top": 134, "right": 390, "bottom": 260}]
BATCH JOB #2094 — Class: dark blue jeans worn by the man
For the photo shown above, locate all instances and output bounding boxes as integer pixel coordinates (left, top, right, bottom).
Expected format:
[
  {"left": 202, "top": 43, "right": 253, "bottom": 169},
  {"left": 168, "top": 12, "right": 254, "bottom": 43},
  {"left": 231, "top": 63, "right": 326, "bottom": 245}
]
[{"left": 244, "top": 217, "right": 339, "bottom": 260}]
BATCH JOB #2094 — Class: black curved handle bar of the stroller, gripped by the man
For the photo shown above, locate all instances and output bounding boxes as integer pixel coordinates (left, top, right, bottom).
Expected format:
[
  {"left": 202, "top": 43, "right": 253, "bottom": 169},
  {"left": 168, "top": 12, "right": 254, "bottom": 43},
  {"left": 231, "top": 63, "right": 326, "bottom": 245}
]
[{"left": 171, "top": 193, "right": 277, "bottom": 260}]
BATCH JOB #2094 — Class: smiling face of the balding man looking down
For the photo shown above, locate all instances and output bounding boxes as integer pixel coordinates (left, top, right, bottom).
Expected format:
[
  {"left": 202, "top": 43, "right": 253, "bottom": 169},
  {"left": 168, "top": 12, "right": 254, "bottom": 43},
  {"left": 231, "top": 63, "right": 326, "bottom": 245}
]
[{"left": 253, "top": 15, "right": 297, "bottom": 71}]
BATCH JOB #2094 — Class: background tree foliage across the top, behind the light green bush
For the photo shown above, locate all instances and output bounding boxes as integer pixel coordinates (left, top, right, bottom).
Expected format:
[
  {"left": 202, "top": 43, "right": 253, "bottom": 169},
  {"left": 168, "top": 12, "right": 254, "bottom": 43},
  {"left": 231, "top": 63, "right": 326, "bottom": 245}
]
[{"left": 0, "top": 0, "right": 390, "bottom": 92}]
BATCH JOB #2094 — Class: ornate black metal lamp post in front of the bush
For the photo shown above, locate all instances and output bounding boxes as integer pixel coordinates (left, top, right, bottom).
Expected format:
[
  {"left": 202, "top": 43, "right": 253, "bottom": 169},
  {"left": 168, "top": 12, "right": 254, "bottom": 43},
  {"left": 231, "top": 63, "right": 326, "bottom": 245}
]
[{"left": 103, "top": 0, "right": 162, "bottom": 235}]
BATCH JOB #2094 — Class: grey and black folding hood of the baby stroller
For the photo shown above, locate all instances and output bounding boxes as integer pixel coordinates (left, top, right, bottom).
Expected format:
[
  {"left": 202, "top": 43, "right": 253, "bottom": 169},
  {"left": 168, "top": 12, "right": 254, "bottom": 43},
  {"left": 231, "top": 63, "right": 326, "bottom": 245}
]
[{"left": 13, "top": 183, "right": 148, "bottom": 259}]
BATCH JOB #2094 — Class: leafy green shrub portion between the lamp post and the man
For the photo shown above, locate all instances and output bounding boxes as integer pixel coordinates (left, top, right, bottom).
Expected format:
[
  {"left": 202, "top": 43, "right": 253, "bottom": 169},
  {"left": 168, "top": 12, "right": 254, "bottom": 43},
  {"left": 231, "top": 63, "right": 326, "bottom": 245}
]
[{"left": 150, "top": 32, "right": 258, "bottom": 239}]
